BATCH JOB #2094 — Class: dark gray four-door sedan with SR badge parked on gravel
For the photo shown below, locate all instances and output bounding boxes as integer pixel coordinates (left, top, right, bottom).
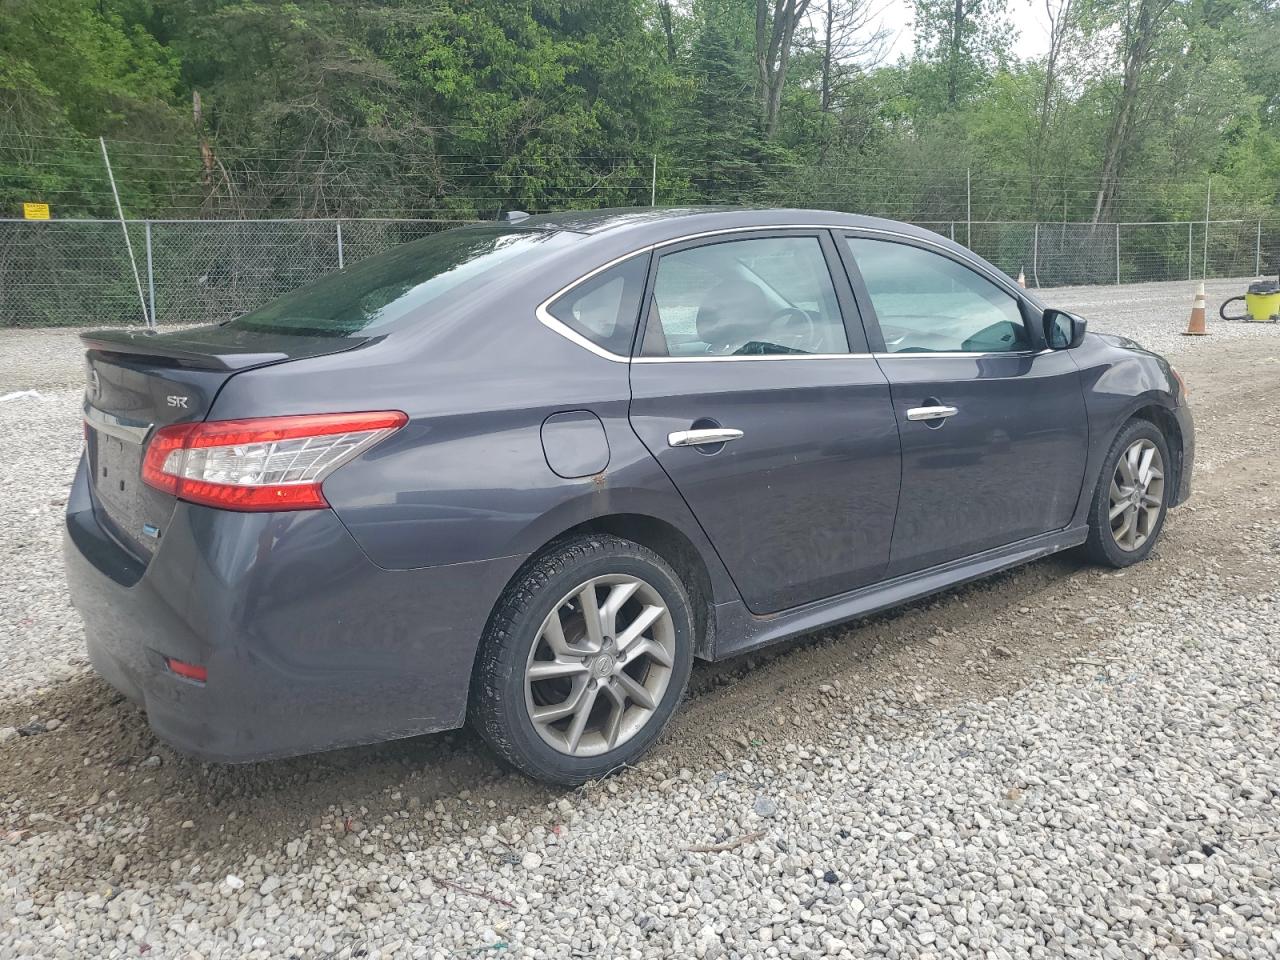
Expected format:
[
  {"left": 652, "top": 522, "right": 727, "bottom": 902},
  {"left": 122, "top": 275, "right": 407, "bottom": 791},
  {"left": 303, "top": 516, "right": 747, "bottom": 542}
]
[{"left": 65, "top": 209, "right": 1193, "bottom": 783}]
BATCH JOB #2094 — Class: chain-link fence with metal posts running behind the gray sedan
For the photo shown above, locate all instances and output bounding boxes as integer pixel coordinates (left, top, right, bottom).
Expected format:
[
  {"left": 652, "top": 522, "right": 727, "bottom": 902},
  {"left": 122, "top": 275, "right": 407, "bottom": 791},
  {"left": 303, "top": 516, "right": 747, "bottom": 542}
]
[{"left": 0, "top": 219, "right": 1280, "bottom": 326}]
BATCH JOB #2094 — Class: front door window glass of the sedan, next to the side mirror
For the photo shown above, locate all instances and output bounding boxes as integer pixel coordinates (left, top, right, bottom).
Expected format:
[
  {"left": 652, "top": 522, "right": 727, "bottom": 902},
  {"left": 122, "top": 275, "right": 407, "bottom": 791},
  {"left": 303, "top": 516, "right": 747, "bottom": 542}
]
[{"left": 845, "top": 237, "right": 1030, "bottom": 353}]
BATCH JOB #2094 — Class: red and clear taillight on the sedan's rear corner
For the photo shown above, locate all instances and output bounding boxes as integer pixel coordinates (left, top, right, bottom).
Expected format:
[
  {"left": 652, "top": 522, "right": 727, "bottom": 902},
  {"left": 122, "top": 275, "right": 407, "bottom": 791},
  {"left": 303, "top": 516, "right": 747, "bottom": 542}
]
[{"left": 142, "top": 410, "right": 408, "bottom": 511}]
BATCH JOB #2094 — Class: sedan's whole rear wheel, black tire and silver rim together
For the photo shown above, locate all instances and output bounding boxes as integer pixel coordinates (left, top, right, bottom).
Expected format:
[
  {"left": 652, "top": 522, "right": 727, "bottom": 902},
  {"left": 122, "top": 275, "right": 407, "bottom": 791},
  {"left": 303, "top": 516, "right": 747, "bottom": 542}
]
[{"left": 468, "top": 534, "right": 694, "bottom": 786}]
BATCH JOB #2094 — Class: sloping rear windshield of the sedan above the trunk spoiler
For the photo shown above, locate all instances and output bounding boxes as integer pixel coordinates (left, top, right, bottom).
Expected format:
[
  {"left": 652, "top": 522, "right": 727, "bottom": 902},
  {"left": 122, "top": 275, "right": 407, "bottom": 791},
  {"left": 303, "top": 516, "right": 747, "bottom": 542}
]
[{"left": 229, "top": 224, "right": 576, "bottom": 337}]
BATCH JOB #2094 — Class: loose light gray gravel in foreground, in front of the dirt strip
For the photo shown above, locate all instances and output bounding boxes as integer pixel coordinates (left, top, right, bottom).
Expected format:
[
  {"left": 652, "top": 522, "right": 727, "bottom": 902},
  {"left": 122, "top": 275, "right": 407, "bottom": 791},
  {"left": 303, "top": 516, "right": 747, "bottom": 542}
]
[{"left": 0, "top": 576, "right": 1280, "bottom": 959}]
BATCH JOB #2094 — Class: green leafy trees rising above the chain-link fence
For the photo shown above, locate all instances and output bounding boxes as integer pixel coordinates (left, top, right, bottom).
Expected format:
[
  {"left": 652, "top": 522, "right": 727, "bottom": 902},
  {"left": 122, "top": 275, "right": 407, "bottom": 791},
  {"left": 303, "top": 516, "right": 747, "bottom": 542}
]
[{"left": 0, "top": 0, "right": 1280, "bottom": 221}]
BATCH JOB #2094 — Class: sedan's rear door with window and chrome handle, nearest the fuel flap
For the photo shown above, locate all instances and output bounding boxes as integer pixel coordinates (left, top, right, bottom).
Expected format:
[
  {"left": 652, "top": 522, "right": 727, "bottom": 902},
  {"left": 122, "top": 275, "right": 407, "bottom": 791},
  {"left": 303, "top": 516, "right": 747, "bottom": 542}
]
[{"left": 631, "top": 230, "right": 900, "bottom": 613}]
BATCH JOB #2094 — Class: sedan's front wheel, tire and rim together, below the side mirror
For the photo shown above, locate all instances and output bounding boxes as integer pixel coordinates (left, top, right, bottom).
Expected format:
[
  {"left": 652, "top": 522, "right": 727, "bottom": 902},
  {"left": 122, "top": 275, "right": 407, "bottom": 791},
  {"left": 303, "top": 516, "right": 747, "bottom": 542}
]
[{"left": 1085, "top": 420, "right": 1175, "bottom": 567}]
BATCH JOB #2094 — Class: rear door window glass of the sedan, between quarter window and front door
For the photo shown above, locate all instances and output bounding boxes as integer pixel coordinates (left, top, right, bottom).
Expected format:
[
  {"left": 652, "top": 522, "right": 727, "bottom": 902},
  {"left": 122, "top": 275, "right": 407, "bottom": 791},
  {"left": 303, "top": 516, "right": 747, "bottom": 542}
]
[{"left": 641, "top": 237, "right": 849, "bottom": 357}]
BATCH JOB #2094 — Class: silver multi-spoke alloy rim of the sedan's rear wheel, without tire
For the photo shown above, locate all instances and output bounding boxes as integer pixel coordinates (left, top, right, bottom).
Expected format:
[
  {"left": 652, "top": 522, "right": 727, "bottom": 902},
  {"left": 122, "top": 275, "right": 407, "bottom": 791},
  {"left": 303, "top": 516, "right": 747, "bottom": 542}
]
[{"left": 525, "top": 573, "right": 676, "bottom": 756}]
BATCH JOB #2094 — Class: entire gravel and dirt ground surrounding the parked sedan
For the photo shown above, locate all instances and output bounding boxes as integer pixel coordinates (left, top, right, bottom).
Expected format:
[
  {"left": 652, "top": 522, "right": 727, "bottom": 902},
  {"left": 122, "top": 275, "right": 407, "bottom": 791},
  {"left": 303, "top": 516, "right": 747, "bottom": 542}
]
[{"left": 0, "top": 273, "right": 1280, "bottom": 959}]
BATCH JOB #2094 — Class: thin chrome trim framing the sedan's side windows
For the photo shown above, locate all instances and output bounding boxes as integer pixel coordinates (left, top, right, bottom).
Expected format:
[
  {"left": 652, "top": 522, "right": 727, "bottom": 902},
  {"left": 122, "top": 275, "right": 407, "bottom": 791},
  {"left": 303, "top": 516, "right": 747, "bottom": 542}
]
[{"left": 534, "top": 224, "right": 1044, "bottom": 364}]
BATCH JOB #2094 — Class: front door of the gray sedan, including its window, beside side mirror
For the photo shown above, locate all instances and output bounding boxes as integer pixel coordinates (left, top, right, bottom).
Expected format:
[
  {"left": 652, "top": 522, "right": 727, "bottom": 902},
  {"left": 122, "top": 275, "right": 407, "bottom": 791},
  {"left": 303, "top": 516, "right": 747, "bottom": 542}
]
[{"left": 841, "top": 232, "right": 1088, "bottom": 576}]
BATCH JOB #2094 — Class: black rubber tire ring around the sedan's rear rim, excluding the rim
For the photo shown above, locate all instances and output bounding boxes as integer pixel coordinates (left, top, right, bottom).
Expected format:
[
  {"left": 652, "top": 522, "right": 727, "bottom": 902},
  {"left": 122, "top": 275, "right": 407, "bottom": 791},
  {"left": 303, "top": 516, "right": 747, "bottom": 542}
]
[{"left": 472, "top": 536, "right": 694, "bottom": 785}]
